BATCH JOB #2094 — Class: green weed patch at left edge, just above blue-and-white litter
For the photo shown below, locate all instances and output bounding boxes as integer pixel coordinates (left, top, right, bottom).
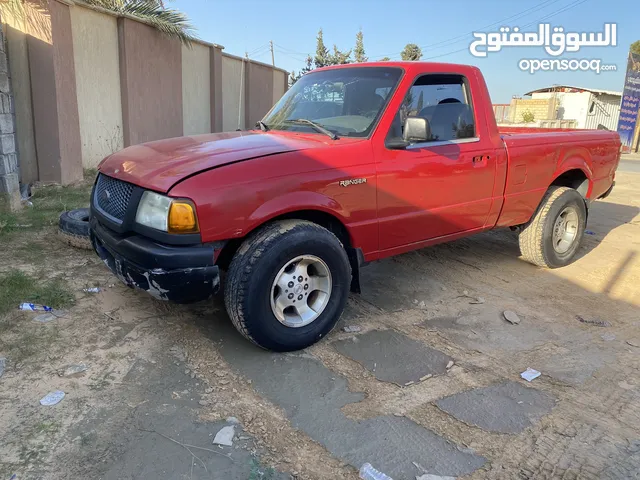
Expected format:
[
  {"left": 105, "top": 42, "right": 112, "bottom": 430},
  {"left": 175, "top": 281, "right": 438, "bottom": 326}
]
[{"left": 0, "top": 270, "right": 74, "bottom": 315}]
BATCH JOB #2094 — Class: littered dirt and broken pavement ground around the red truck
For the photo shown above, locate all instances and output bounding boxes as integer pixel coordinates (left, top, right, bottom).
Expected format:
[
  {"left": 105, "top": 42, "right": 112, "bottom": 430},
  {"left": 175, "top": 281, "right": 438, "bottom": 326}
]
[{"left": 0, "top": 173, "right": 640, "bottom": 480}]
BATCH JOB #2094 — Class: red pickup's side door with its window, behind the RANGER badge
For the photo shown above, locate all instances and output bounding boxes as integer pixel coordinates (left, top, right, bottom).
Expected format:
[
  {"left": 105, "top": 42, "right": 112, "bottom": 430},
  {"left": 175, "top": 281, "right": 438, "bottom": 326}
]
[{"left": 377, "top": 74, "right": 497, "bottom": 250}]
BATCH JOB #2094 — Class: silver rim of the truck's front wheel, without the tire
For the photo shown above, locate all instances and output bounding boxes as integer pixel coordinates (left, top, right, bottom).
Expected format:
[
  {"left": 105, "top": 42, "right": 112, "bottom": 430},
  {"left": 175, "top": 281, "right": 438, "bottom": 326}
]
[{"left": 271, "top": 255, "right": 332, "bottom": 328}]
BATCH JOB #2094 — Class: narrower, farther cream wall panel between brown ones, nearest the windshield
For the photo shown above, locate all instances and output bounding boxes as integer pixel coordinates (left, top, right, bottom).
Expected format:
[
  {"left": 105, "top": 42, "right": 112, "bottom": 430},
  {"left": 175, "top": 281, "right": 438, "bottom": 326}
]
[{"left": 222, "top": 54, "right": 245, "bottom": 132}]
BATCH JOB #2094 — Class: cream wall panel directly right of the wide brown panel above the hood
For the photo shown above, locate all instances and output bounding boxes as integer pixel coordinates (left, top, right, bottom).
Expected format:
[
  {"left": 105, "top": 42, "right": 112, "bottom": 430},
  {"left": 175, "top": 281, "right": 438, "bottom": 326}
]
[{"left": 182, "top": 44, "right": 211, "bottom": 135}]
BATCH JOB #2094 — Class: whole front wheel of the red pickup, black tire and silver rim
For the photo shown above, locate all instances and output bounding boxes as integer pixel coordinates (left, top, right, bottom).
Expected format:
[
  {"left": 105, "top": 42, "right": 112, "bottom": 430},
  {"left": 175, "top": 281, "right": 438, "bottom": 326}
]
[{"left": 224, "top": 220, "right": 351, "bottom": 352}]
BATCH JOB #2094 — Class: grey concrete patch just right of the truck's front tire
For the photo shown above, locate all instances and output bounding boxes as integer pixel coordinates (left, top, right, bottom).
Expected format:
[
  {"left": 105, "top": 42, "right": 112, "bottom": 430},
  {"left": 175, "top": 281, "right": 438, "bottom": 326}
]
[{"left": 333, "top": 330, "right": 452, "bottom": 386}]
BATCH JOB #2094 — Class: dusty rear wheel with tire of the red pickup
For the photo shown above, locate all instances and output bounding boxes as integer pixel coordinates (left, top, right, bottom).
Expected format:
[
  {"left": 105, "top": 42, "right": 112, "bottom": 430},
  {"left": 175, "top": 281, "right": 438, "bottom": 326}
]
[{"left": 519, "top": 187, "right": 587, "bottom": 268}]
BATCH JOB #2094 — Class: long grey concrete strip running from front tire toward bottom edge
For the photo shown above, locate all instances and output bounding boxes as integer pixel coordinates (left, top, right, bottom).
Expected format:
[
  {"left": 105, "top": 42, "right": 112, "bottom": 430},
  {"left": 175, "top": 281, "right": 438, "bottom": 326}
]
[{"left": 219, "top": 318, "right": 486, "bottom": 480}]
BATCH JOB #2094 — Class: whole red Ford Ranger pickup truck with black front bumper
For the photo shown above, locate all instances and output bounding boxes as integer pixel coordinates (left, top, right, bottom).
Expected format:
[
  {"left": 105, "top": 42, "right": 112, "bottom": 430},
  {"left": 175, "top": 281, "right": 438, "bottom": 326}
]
[{"left": 90, "top": 62, "right": 620, "bottom": 351}]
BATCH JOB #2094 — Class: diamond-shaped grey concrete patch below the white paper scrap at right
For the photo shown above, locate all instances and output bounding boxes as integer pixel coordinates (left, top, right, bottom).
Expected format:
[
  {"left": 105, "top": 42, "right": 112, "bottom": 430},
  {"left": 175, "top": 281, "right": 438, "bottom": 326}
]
[{"left": 436, "top": 382, "right": 555, "bottom": 433}]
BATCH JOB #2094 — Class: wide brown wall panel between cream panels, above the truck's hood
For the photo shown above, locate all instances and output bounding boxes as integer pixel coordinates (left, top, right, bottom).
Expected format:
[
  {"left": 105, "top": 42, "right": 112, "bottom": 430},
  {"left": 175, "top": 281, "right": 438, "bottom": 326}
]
[{"left": 118, "top": 18, "right": 182, "bottom": 146}]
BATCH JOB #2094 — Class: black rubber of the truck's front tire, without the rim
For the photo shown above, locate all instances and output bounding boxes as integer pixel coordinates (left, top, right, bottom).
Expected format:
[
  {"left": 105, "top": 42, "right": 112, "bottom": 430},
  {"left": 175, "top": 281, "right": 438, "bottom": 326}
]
[{"left": 224, "top": 220, "right": 351, "bottom": 352}]
